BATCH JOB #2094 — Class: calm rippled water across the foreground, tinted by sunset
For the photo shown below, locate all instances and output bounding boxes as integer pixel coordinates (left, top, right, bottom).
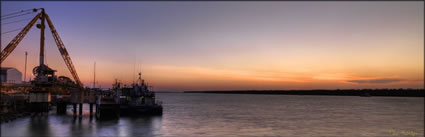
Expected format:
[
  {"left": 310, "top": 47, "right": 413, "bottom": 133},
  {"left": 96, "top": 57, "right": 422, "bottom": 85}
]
[{"left": 1, "top": 93, "right": 424, "bottom": 137}]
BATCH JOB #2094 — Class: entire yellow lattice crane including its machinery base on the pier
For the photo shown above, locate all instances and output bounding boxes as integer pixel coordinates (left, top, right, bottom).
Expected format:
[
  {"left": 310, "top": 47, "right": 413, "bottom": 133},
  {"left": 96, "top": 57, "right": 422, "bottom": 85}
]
[{"left": 0, "top": 8, "right": 95, "bottom": 114}]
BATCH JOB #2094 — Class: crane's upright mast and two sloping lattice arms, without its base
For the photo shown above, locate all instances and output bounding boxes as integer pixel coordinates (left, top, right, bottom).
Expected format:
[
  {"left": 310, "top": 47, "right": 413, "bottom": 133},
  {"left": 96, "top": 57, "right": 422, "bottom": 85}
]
[{"left": 0, "top": 8, "right": 83, "bottom": 88}]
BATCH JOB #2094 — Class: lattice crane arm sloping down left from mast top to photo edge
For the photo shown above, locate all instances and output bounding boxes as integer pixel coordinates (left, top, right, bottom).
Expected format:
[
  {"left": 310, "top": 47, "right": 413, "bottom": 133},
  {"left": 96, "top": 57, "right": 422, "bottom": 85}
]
[{"left": 0, "top": 13, "right": 41, "bottom": 63}]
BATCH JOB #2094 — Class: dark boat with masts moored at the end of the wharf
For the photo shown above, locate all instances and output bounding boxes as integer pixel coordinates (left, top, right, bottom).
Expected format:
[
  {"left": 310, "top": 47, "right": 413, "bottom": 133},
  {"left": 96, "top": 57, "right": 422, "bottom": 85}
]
[{"left": 96, "top": 73, "right": 163, "bottom": 119}]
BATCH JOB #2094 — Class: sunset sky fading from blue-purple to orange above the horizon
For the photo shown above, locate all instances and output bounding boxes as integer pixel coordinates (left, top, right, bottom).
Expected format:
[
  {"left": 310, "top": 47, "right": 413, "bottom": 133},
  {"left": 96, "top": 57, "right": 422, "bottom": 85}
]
[{"left": 1, "top": 1, "right": 424, "bottom": 91}]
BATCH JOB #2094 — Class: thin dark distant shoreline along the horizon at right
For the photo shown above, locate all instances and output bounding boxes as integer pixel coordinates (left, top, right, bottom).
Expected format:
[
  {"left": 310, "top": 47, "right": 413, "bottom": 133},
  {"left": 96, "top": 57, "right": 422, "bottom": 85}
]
[{"left": 183, "top": 89, "right": 425, "bottom": 97}]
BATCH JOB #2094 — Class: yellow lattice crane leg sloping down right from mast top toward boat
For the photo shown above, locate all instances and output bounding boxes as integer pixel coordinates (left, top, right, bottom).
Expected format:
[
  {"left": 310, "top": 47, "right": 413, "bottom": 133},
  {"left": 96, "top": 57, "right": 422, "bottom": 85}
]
[{"left": 44, "top": 13, "right": 83, "bottom": 88}]
